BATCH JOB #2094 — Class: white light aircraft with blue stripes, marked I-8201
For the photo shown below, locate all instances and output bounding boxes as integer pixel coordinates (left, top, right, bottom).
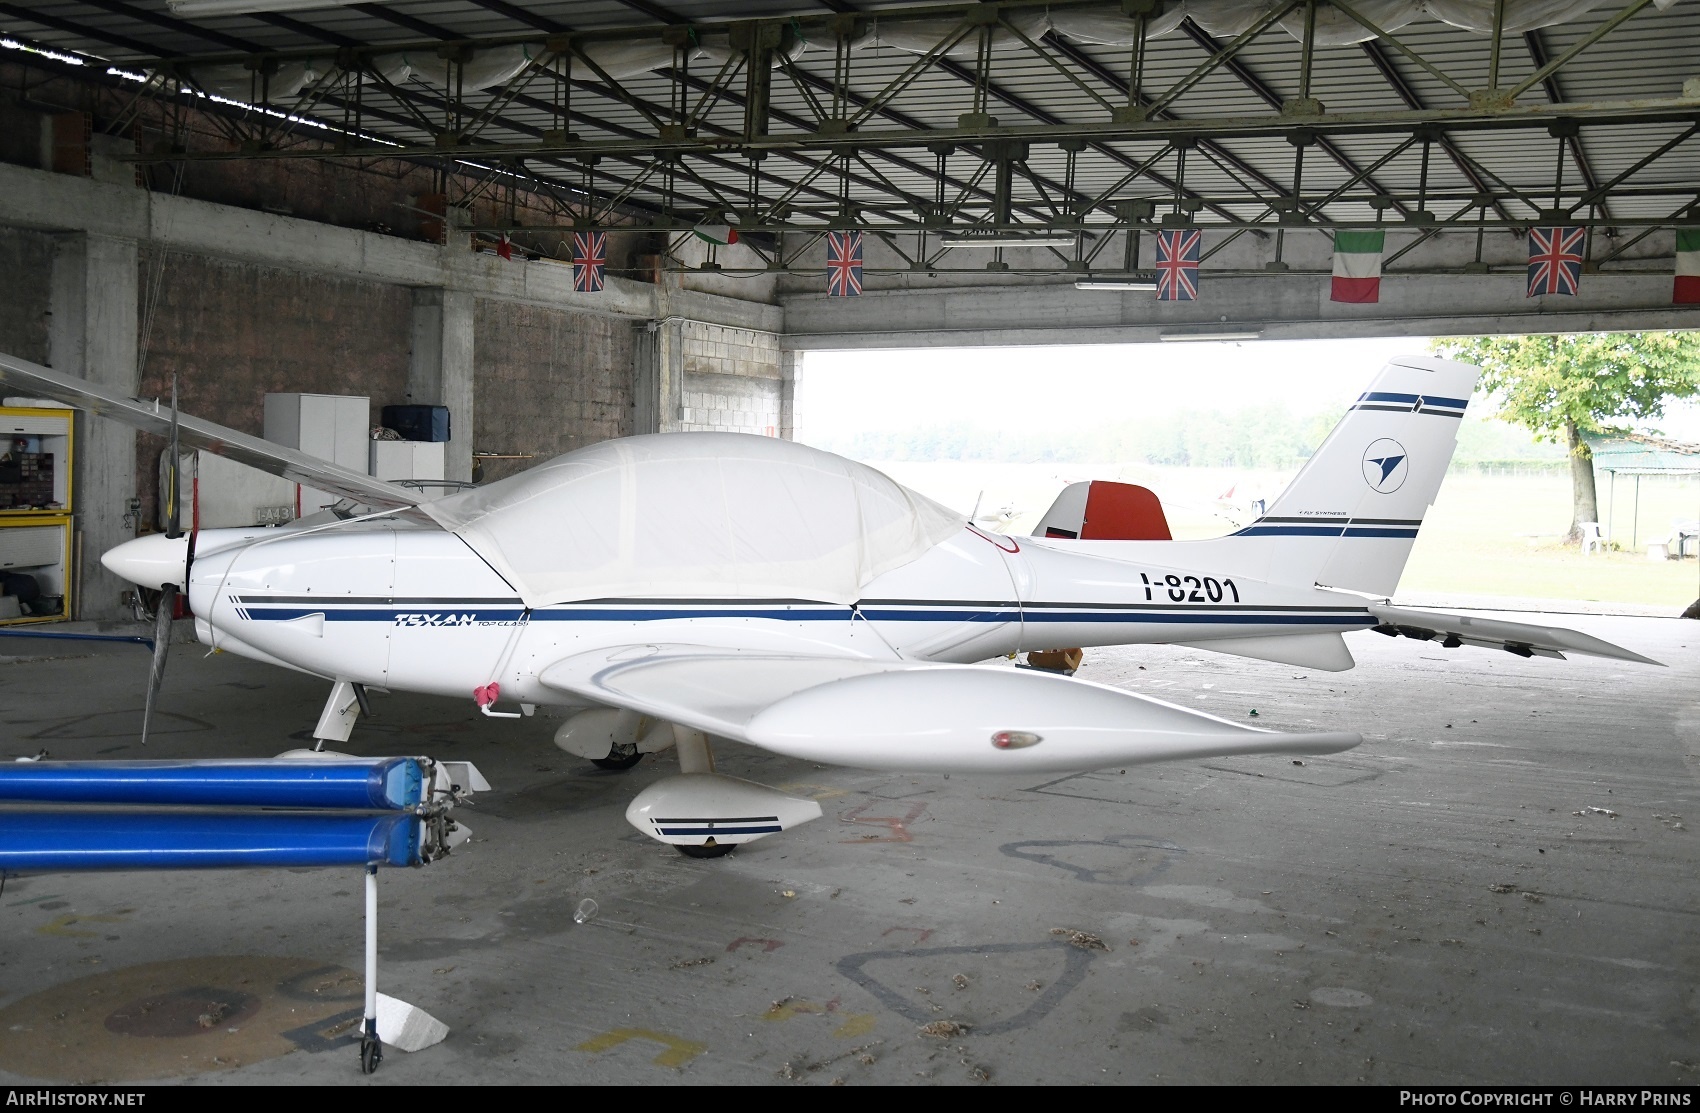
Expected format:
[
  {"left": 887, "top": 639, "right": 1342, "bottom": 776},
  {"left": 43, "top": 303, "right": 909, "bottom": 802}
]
[{"left": 0, "top": 357, "right": 1656, "bottom": 856}]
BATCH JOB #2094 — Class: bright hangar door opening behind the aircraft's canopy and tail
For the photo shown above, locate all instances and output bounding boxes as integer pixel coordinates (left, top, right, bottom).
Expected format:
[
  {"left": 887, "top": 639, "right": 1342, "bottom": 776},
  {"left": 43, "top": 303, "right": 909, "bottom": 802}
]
[{"left": 796, "top": 336, "right": 1700, "bottom": 613}]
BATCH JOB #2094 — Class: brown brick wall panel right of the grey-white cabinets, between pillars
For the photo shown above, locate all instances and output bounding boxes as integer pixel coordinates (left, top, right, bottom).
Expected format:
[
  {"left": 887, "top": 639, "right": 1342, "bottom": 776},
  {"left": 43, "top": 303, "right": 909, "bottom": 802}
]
[{"left": 473, "top": 299, "right": 641, "bottom": 481}]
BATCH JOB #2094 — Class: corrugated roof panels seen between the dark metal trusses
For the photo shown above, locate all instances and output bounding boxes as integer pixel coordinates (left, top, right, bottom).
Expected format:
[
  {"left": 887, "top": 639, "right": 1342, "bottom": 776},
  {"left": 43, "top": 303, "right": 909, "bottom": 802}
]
[{"left": 0, "top": 0, "right": 1700, "bottom": 244}]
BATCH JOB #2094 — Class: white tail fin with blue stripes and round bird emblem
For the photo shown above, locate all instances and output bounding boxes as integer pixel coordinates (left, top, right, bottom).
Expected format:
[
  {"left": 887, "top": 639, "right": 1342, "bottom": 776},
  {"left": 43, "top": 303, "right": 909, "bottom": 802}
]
[{"left": 1219, "top": 355, "right": 1481, "bottom": 595}]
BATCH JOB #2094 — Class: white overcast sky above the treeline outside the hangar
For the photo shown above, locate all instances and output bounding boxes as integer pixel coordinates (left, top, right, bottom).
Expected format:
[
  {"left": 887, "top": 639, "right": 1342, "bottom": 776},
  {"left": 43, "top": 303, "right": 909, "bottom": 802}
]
[{"left": 797, "top": 336, "right": 1700, "bottom": 442}]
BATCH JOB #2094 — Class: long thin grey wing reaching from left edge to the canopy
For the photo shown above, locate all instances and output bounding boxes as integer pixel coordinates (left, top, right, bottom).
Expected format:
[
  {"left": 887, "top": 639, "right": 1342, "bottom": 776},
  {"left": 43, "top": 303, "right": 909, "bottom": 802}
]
[{"left": 0, "top": 353, "right": 425, "bottom": 510}]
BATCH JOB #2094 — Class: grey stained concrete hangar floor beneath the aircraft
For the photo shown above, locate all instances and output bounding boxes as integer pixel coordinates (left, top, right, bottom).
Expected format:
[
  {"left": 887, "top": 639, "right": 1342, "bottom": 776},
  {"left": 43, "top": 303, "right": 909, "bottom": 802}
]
[{"left": 0, "top": 615, "right": 1700, "bottom": 1086}]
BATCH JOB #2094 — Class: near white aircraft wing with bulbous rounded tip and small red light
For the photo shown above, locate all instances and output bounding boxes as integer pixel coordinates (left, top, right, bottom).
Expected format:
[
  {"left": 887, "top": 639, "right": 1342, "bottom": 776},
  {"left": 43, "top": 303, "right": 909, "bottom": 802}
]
[{"left": 539, "top": 646, "right": 1362, "bottom": 773}]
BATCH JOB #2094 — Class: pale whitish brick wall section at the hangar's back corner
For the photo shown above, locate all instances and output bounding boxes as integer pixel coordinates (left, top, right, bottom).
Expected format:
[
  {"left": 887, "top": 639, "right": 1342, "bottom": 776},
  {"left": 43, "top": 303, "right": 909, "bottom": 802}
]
[{"left": 680, "top": 321, "right": 780, "bottom": 437}]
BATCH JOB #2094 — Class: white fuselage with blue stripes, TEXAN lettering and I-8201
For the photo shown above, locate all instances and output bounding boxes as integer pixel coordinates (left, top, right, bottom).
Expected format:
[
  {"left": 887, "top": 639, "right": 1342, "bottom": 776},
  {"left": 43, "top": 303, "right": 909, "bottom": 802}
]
[{"left": 189, "top": 522, "right": 1375, "bottom": 703}]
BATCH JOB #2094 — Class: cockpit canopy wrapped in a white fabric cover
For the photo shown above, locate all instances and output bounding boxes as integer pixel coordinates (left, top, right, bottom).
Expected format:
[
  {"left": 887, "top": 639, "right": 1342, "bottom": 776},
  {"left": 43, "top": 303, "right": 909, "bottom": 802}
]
[{"left": 422, "top": 433, "right": 966, "bottom": 607}]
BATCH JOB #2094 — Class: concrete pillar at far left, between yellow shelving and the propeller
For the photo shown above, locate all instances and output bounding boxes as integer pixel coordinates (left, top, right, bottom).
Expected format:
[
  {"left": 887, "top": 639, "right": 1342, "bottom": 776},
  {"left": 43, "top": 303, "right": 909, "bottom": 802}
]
[{"left": 48, "top": 234, "right": 141, "bottom": 622}]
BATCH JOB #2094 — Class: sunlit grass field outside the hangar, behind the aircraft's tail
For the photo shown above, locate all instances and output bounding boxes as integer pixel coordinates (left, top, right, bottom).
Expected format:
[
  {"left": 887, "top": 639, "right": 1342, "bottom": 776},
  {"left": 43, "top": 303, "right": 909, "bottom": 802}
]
[{"left": 874, "top": 460, "right": 1700, "bottom": 613}]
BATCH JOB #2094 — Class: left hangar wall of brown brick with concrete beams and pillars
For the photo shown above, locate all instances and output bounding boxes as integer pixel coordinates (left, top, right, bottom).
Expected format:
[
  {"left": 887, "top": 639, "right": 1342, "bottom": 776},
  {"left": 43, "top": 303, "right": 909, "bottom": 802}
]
[{"left": 0, "top": 161, "right": 789, "bottom": 620}]
